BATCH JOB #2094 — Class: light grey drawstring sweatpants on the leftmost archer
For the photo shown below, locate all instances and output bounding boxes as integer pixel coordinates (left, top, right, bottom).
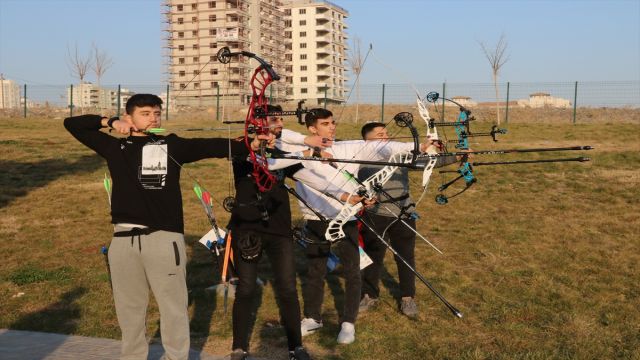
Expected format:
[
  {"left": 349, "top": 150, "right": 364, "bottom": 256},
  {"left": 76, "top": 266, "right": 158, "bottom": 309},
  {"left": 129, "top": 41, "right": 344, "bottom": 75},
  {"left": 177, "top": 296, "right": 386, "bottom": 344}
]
[{"left": 109, "top": 226, "right": 189, "bottom": 360}]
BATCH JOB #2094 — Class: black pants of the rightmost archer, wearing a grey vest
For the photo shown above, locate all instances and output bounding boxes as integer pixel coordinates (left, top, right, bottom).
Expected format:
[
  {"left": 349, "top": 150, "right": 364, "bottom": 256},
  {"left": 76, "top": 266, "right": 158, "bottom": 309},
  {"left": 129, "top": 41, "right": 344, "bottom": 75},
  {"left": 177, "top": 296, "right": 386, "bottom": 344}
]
[{"left": 361, "top": 212, "right": 416, "bottom": 298}]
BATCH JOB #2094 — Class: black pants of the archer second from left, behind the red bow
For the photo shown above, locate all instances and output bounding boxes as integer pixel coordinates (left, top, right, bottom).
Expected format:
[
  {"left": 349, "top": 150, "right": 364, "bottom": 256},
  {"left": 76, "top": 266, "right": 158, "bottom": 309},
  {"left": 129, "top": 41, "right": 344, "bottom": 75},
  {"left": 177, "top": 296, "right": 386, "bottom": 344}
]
[{"left": 231, "top": 230, "right": 302, "bottom": 351}]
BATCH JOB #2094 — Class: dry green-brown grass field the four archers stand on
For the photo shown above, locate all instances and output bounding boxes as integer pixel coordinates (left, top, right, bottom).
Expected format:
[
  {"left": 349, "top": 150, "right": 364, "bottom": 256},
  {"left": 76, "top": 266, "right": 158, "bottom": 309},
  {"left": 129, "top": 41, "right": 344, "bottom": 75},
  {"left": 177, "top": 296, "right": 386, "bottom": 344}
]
[{"left": 0, "top": 106, "right": 640, "bottom": 359}]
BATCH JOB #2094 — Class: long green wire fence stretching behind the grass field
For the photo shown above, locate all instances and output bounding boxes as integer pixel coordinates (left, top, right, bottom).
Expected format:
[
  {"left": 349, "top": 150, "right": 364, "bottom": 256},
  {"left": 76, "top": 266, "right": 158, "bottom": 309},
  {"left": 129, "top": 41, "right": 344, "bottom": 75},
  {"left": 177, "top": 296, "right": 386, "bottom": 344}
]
[{"left": 1, "top": 81, "right": 640, "bottom": 122}]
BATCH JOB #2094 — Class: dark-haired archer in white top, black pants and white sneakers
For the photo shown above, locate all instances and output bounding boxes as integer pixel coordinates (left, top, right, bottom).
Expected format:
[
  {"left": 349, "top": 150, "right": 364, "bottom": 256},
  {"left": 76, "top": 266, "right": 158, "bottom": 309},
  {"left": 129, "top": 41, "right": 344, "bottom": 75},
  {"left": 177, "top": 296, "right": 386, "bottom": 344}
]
[{"left": 279, "top": 109, "right": 426, "bottom": 344}]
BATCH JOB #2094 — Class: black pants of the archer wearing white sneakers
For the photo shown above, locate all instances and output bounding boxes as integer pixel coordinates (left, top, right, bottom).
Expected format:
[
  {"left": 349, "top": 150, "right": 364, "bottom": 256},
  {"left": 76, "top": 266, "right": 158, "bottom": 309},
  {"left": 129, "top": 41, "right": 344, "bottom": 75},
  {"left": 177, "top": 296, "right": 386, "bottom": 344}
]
[{"left": 303, "top": 221, "right": 361, "bottom": 323}]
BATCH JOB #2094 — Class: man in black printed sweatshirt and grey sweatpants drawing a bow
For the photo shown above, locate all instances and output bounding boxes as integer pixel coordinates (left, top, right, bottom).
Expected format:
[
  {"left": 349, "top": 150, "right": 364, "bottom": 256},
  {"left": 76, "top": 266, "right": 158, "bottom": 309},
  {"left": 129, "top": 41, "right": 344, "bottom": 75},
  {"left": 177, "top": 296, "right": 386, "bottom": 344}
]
[{"left": 64, "top": 94, "right": 259, "bottom": 360}]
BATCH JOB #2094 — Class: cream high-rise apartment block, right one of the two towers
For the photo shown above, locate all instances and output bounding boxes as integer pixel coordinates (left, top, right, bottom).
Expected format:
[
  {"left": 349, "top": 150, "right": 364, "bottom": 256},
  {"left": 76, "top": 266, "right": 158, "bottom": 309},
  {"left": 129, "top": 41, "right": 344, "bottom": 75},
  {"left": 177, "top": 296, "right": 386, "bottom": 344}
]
[{"left": 283, "top": 0, "right": 349, "bottom": 104}]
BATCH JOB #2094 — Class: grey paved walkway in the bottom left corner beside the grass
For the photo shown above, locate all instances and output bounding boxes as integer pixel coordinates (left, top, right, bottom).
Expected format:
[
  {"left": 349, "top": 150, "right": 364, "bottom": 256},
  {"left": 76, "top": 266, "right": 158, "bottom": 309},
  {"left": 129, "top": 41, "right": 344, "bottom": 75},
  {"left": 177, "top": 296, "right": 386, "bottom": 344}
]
[{"left": 0, "top": 329, "right": 229, "bottom": 360}]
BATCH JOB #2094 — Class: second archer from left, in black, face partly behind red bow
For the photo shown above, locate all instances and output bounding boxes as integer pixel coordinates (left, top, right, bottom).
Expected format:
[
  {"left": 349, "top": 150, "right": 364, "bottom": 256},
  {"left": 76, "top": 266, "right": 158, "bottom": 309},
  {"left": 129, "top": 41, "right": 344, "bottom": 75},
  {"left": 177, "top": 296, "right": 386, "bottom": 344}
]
[{"left": 228, "top": 105, "right": 361, "bottom": 360}]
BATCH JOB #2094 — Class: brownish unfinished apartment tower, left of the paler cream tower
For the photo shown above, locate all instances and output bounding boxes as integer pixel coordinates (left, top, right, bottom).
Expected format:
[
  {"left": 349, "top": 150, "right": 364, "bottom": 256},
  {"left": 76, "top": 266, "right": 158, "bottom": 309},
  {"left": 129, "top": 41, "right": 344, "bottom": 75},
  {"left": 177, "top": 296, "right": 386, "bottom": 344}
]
[{"left": 163, "top": 0, "right": 286, "bottom": 106}]
